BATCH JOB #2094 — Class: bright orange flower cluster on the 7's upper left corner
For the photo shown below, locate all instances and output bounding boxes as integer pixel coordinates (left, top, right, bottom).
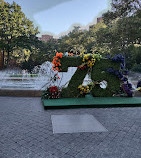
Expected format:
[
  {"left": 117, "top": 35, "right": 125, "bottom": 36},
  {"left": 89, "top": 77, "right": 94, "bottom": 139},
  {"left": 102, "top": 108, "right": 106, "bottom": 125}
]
[{"left": 52, "top": 52, "right": 63, "bottom": 71}]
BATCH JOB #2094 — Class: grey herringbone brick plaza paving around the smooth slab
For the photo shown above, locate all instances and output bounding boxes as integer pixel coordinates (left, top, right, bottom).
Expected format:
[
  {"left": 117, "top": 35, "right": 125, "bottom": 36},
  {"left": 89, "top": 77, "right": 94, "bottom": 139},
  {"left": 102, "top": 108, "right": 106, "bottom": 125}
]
[{"left": 0, "top": 97, "right": 141, "bottom": 158}]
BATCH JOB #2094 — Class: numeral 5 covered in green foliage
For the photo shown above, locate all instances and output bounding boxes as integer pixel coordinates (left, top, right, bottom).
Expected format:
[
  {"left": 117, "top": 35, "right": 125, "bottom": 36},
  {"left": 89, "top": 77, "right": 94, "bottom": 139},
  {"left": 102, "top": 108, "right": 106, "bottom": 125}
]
[{"left": 91, "top": 59, "right": 120, "bottom": 97}]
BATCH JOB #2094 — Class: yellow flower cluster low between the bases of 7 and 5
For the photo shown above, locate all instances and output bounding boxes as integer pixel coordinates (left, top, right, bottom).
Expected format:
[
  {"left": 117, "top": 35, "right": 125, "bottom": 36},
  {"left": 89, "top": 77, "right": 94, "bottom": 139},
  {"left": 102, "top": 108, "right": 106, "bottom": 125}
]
[{"left": 78, "top": 82, "right": 94, "bottom": 95}]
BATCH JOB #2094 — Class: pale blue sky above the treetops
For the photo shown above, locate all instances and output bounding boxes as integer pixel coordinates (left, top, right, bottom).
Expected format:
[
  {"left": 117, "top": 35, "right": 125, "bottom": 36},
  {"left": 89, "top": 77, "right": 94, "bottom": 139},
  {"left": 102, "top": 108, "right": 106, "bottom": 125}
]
[{"left": 5, "top": 0, "right": 110, "bottom": 37}]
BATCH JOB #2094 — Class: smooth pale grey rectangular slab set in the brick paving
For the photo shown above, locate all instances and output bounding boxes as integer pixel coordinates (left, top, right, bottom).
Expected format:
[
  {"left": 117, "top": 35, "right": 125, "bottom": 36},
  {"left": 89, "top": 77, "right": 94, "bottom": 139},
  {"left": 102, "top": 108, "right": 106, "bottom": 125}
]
[{"left": 51, "top": 114, "right": 107, "bottom": 133}]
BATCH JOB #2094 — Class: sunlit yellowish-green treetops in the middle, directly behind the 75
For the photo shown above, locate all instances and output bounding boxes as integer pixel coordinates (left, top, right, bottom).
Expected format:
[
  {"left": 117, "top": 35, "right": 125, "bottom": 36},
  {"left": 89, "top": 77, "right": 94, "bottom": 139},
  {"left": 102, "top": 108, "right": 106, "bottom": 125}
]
[{"left": 58, "top": 22, "right": 106, "bottom": 55}]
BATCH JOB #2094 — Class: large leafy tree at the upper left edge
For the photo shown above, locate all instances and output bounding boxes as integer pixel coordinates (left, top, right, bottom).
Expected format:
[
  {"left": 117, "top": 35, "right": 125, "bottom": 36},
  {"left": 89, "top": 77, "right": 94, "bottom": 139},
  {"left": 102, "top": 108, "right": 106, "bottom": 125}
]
[{"left": 0, "top": 0, "right": 38, "bottom": 65}]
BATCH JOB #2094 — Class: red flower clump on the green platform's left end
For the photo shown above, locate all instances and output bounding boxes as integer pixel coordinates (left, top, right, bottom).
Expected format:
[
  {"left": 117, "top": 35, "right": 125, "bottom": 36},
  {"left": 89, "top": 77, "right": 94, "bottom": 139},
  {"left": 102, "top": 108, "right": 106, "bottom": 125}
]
[{"left": 42, "top": 86, "right": 61, "bottom": 99}]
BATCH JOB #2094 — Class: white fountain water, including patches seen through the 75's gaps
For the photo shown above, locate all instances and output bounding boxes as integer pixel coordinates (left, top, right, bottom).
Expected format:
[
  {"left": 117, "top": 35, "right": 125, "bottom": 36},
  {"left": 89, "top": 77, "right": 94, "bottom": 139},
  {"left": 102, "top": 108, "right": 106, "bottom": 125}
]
[{"left": 0, "top": 61, "right": 90, "bottom": 90}]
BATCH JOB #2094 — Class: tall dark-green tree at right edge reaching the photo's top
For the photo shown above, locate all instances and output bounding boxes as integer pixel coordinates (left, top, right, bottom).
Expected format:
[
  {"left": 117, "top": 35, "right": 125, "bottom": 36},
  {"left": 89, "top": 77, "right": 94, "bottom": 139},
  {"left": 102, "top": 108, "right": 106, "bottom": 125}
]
[{"left": 99, "top": 0, "right": 141, "bottom": 69}]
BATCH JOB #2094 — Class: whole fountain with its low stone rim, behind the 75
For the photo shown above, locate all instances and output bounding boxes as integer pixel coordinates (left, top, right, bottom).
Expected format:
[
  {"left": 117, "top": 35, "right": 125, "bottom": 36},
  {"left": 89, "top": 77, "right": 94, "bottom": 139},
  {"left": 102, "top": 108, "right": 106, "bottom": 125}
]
[{"left": 0, "top": 61, "right": 136, "bottom": 96}]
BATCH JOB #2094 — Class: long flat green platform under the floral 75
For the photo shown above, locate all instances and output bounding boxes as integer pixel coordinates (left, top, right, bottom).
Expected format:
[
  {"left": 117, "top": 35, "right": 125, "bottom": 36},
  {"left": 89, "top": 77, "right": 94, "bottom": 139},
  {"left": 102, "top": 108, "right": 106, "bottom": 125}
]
[{"left": 42, "top": 95, "right": 141, "bottom": 107}]
